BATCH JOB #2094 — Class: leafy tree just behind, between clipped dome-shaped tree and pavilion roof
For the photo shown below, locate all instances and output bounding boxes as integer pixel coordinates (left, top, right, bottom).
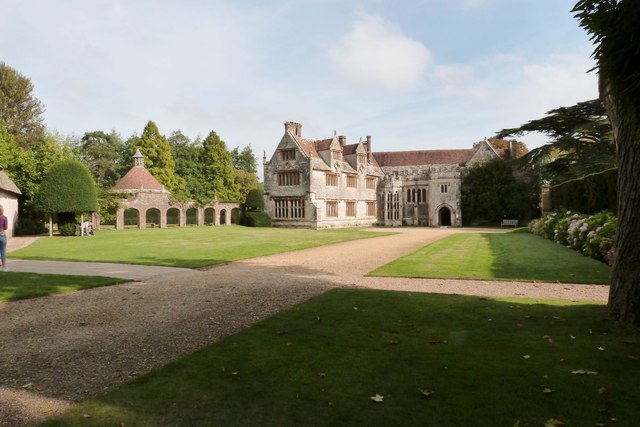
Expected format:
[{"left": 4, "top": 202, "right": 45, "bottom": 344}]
[{"left": 77, "top": 131, "right": 124, "bottom": 189}]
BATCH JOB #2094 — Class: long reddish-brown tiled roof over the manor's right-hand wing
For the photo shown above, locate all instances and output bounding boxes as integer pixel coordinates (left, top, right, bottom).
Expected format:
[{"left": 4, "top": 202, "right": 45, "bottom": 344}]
[{"left": 373, "top": 149, "right": 476, "bottom": 167}]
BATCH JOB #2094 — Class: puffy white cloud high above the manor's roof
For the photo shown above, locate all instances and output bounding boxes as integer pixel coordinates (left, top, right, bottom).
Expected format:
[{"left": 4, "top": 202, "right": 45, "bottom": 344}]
[{"left": 329, "top": 15, "right": 431, "bottom": 90}]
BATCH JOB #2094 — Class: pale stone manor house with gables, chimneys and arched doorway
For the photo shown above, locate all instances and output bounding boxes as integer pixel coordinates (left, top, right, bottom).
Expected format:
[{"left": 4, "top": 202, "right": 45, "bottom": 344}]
[{"left": 264, "top": 122, "right": 506, "bottom": 228}]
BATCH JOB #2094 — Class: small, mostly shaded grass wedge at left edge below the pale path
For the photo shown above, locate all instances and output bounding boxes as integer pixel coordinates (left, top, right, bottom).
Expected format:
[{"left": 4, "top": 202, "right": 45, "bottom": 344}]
[{"left": 0, "top": 272, "right": 126, "bottom": 301}]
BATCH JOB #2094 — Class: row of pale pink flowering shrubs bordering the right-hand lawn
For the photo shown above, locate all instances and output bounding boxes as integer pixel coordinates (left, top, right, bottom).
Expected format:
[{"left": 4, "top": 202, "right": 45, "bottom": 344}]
[{"left": 529, "top": 211, "right": 618, "bottom": 265}]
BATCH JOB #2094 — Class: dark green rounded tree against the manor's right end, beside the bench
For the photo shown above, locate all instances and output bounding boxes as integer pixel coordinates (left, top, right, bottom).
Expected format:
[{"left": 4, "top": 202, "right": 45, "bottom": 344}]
[{"left": 461, "top": 158, "right": 538, "bottom": 225}]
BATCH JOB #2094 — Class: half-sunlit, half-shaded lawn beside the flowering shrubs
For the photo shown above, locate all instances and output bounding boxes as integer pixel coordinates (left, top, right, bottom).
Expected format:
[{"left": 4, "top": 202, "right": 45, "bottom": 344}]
[{"left": 369, "top": 231, "right": 610, "bottom": 284}]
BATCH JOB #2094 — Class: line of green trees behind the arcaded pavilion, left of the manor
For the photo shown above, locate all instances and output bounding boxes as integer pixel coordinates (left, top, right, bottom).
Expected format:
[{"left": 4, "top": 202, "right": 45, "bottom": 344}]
[{"left": 0, "top": 62, "right": 259, "bottom": 231}]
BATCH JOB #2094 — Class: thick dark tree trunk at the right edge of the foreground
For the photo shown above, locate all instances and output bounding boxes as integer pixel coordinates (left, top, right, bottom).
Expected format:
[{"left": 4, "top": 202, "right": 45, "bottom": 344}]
[{"left": 600, "top": 82, "right": 640, "bottom": 326}]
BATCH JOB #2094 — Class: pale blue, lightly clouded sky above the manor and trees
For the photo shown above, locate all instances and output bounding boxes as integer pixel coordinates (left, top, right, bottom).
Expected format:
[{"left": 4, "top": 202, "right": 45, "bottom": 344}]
[{"left": 0, "top": 0, "right": 598, "bottom": 172}]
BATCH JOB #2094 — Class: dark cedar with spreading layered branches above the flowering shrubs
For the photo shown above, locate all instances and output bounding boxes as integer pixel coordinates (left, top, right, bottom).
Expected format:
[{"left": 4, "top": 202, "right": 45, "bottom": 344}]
[{"left": 498, "top": 99, "right": 616, "bottom": 184}]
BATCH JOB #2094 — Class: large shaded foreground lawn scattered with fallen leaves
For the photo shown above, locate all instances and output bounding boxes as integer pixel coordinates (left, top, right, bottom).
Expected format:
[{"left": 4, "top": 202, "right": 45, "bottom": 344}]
[{"left": 44, "top": 289, "right": 640, "bottom": 426}]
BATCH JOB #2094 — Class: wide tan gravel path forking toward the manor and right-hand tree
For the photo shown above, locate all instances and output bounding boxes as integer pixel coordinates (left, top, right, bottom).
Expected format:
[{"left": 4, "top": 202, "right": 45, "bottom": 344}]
[{"left": 0, "top": 228, "right": 608, "bottom": 426}]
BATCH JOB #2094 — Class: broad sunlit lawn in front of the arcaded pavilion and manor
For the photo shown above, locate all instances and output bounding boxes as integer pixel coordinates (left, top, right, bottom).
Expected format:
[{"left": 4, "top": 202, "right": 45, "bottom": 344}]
[{"left": 10, "top": 226, "right": 384, "bottom": 268}]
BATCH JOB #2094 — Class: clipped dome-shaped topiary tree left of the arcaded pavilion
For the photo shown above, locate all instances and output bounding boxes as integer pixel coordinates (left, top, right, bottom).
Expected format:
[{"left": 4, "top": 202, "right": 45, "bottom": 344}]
[{"left": 34, "top": 159, "right": 98, "bottom": 234}]
